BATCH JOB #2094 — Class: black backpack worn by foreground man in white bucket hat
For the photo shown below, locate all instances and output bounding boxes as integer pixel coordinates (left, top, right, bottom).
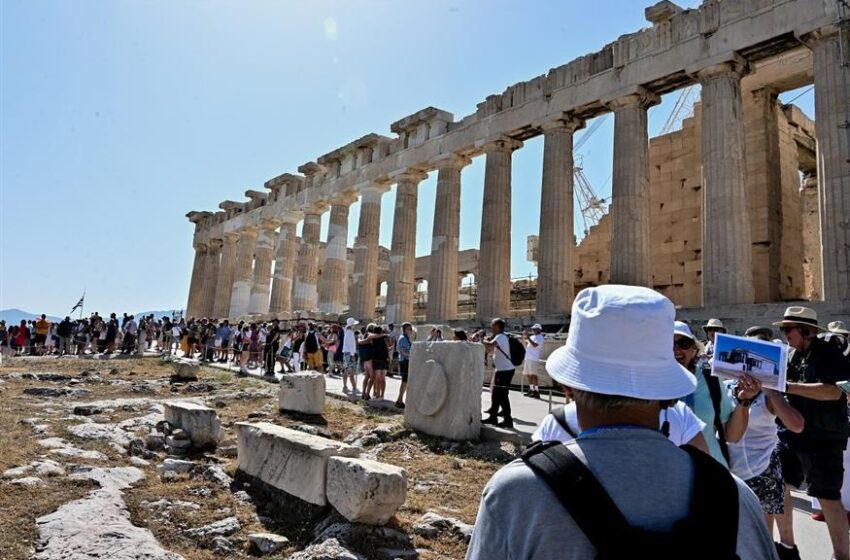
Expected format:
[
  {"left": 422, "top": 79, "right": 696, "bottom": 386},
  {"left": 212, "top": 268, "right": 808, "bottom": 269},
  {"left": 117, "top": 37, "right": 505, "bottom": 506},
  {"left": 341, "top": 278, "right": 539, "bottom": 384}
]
[{"left": 522, "top": 441, "right": 739, "bottom": 560}]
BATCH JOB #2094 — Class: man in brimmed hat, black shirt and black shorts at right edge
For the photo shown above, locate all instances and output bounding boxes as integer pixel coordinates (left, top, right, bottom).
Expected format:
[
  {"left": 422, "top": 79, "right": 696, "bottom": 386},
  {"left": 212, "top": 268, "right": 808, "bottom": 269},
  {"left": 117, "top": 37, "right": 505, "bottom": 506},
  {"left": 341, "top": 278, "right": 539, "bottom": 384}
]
[{"left": 773, "top": 305, "right": 850, "bottom": 560}]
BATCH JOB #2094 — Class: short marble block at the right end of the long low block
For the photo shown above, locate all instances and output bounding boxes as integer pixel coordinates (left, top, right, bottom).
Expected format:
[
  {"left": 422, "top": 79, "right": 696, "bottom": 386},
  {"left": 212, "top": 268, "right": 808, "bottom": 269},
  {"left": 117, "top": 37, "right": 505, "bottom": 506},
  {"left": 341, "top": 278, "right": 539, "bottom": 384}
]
[{"left": 327, "top": 457, "right": 407, "bottom": 525}]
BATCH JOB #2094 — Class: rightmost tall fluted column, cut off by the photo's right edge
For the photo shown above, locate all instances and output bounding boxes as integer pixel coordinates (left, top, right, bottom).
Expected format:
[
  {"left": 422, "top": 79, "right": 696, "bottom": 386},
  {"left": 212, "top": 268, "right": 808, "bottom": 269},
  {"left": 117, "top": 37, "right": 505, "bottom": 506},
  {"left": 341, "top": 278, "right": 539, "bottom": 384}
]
[{"left": 808, "top": 29, "right": 850, "bottom": 301}]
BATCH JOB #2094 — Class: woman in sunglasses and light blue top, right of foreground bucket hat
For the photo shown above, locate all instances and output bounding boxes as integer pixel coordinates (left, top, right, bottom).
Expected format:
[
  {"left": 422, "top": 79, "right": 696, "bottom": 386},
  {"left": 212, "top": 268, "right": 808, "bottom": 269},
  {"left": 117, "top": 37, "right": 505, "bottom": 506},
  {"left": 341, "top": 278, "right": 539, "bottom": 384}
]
[{"left": 673, "top": 321, "right": 761, "bottom": 467}]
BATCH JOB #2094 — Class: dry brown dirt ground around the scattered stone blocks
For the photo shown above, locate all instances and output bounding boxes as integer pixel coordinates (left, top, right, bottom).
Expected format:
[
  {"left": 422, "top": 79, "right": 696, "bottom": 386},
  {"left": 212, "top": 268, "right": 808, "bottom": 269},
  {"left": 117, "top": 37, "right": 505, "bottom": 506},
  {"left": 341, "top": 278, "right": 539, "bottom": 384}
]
[{"left": 0, "top": 358, "right": 510, "bottom": 560}]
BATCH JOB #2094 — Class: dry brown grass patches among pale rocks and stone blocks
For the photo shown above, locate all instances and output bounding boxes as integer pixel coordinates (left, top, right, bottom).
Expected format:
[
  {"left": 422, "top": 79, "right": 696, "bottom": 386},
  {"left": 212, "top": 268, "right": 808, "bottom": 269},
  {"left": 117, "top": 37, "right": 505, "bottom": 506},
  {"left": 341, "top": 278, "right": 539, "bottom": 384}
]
[{"left": 0, "top": 358, "right": 514, "bottom": 560}]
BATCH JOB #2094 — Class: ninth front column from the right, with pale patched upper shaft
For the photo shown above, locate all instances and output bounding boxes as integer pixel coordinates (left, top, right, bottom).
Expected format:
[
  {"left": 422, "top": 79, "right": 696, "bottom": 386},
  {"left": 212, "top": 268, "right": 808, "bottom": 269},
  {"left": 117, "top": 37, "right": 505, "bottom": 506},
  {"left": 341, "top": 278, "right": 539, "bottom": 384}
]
[{"left": 319, "top": 194, "right": 357, "bottom": 314}]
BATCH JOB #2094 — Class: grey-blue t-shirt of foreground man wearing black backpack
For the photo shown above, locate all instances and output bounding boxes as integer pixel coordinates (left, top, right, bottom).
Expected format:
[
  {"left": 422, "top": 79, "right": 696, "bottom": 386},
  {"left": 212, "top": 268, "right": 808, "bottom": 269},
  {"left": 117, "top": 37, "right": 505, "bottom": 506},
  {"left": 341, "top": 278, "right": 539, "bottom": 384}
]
[{"left": 466, "top": 429, "right": 776, "bottom": 560}]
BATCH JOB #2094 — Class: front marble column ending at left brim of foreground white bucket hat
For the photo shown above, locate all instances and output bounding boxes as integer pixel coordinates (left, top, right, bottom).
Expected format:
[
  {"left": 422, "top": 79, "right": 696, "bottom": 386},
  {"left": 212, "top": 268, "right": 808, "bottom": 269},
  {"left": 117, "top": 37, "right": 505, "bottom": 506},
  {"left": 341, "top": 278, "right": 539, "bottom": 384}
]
[{"left": 537, "top": 118, "right": 584, "bottom": 315}]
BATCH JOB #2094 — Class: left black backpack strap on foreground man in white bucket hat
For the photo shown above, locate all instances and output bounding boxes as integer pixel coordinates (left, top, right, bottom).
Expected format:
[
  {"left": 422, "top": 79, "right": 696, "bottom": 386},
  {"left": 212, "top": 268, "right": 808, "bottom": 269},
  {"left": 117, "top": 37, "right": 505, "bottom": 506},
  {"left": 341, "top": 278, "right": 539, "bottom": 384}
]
[{"left": 522, "top": 441, "right": 632, "bottom": 558}]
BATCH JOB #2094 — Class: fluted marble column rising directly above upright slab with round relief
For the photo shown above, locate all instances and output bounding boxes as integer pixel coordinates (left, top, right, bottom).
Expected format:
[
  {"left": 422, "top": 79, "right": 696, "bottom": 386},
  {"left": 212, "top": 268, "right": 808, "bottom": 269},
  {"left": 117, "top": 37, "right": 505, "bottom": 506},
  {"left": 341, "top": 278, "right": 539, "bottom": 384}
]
[{"left": 428, "top": 154, "right": 470, "bottom": 323}]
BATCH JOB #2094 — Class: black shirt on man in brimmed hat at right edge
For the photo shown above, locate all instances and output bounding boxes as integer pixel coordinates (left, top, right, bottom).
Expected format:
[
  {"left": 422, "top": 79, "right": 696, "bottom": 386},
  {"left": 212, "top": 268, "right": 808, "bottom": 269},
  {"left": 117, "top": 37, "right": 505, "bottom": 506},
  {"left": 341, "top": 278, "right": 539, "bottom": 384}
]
[{"left": 780, "top": 338, "right": 850, "bottom": 442}]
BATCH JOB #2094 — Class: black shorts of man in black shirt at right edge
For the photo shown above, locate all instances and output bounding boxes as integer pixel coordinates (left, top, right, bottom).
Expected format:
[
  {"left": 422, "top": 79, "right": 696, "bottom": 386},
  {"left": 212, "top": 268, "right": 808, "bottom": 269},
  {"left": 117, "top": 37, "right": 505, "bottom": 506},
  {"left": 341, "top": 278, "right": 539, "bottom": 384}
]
[{"left": 779, "top": 440, "right": 847, "bottom": 500}]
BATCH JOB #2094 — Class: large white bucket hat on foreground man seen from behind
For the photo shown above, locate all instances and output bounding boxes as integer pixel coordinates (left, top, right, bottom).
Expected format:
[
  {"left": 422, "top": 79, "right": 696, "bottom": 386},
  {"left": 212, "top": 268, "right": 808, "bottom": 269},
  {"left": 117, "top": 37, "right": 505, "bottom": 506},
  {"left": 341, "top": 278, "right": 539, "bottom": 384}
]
[{"left": 546, "top": 284, "right": 696, "bottom": 400}]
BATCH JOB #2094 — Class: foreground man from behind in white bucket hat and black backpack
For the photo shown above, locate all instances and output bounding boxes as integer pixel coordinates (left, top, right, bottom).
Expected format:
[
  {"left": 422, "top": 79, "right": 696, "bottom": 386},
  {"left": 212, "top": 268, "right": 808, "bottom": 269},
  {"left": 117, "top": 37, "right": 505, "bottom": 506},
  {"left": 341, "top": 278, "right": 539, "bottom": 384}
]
[{"left": 466, "top": 285, "right": 775, "bottom": 560}]
